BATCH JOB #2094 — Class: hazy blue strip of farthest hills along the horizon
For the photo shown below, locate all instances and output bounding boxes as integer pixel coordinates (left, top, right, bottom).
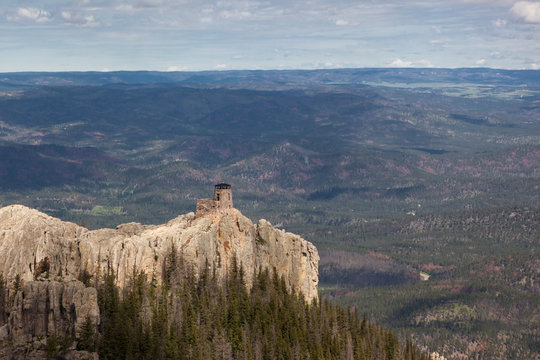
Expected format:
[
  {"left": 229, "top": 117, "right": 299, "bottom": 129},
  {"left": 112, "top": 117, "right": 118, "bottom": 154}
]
[{"left": 0, "top": 68, "right": 539, "bottom": 95}]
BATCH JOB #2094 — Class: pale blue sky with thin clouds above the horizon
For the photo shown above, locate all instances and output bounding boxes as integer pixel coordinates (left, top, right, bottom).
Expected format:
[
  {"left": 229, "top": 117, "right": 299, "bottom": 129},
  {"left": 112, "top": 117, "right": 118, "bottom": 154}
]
[{"left": 0, "top": 0, "right": 540, "bottom": 72}]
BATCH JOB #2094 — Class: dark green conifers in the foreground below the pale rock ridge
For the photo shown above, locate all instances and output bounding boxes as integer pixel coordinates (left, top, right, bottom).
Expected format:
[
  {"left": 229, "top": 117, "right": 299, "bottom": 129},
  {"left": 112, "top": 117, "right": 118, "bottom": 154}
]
[{"left": 0, "top": 251, "right": 429, "bottom": 360}]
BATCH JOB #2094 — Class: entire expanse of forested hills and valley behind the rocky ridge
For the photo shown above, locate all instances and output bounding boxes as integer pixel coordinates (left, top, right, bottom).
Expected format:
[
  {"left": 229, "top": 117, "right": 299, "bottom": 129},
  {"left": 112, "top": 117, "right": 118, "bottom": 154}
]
[{"left": 0, "top": 69, "right": 540, "bottom": 358}]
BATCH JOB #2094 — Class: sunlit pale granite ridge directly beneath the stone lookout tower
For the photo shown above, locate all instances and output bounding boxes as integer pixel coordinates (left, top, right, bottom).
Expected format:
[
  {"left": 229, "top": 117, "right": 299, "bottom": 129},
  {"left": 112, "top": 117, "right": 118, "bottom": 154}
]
[{"left": 0, "top": 205, "right": 319, "bottom": 300}]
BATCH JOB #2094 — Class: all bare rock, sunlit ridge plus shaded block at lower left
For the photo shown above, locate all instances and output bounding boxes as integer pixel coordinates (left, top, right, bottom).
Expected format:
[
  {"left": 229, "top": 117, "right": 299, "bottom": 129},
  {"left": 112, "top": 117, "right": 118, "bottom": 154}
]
[{"left": 0, "top": 205, "right": 319, "bottom": 356}]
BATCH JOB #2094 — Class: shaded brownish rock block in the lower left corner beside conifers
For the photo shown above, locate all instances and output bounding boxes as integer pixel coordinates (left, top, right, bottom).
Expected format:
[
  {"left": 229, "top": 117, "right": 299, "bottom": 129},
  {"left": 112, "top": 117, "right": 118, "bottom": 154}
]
[{"left": 0, "top": 277, "right": 100, "bottom": 360}]
